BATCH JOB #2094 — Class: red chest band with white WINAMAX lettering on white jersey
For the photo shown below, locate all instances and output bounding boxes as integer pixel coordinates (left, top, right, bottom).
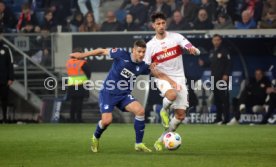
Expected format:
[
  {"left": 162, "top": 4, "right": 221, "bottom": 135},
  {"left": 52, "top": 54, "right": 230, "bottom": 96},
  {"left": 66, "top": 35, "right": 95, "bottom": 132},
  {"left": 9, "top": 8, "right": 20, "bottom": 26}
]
[{"left": 152, "top": 45, "right": 182, "bottom": 63}]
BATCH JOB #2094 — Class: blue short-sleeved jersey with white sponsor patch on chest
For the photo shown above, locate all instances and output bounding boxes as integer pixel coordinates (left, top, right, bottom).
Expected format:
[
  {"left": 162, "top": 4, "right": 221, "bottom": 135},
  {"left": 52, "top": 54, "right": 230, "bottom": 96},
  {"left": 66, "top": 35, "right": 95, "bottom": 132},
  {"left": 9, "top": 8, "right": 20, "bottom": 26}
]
[{"left": 103, "top": 48, "right": 150, "bottom": 95}]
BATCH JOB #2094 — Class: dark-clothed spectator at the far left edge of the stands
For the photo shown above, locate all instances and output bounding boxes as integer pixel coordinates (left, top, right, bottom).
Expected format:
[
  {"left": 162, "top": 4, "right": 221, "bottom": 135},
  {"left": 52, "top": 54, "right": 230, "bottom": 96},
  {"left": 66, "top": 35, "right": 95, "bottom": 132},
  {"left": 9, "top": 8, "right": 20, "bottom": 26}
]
[{"left": 0, "top": 1, "right": 16, "bottom": 32}]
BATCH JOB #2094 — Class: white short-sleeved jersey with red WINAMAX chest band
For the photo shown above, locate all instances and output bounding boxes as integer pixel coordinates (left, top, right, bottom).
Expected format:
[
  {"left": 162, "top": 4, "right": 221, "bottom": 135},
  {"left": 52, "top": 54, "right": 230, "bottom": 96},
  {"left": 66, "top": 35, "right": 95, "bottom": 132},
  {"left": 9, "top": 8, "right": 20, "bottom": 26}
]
[{"left": 144, "top": 32, "right": 192, "bottom": 77}]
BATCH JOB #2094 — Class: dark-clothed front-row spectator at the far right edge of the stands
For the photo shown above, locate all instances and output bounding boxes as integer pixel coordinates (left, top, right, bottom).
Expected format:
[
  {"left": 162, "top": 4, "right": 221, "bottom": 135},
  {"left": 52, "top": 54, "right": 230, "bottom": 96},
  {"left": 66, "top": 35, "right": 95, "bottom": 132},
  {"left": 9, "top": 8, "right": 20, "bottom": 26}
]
[{"left": 258, "top": 8, "right": 276, "bottom": 28}]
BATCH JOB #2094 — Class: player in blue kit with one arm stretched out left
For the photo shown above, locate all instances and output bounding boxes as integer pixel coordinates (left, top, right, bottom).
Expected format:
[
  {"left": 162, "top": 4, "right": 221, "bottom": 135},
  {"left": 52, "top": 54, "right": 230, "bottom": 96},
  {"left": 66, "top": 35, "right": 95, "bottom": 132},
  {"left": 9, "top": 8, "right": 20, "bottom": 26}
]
[{"left": 70, "top": 40, "right": 172, "bottom": 152}]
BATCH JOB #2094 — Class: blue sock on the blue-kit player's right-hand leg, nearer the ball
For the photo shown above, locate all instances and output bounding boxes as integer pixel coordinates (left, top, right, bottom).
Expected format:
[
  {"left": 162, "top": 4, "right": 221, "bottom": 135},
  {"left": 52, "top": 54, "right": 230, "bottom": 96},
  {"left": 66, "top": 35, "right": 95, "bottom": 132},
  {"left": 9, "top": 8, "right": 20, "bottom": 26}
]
[{"left": 134, "top": 116, "right": 145, "bottom": 144}]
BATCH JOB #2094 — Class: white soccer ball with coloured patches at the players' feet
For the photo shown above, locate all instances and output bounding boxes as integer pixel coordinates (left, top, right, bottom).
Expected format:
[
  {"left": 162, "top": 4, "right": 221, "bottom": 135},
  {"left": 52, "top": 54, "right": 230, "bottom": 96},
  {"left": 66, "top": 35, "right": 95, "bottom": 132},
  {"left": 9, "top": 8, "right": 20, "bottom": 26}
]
[{"left": 163, "top": 132, "right": 181, "bottom": 150}]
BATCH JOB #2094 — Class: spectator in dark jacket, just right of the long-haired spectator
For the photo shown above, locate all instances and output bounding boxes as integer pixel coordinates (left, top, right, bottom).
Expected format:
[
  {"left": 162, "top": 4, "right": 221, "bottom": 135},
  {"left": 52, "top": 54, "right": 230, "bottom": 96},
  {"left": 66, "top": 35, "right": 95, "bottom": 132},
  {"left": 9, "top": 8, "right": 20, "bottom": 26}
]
[{"left": 101, "top": 11, "right": 120, "bottom": 31}]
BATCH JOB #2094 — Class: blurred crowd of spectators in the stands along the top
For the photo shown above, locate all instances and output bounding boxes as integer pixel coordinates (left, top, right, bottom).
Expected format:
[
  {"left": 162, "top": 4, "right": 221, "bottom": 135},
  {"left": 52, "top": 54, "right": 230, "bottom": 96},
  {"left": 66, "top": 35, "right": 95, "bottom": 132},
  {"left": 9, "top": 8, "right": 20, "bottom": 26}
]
[{"left": 0, "top": 0, "right": 276, "bottom": 33}]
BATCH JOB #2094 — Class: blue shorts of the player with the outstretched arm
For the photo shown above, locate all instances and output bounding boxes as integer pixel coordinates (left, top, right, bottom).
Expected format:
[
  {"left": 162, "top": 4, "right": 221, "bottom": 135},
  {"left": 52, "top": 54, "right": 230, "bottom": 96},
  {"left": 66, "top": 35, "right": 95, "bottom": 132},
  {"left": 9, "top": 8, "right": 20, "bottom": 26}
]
[{"left": 99, "top": 90, "right": 136, "bottom": 113}]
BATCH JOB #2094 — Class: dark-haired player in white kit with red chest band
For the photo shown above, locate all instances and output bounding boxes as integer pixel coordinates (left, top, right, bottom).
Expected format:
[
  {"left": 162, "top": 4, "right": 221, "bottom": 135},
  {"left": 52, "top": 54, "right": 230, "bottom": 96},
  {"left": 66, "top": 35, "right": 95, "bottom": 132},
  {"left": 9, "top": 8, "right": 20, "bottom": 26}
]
[{"left": 144, "top": 13, "right": 200, "bottom": 151}]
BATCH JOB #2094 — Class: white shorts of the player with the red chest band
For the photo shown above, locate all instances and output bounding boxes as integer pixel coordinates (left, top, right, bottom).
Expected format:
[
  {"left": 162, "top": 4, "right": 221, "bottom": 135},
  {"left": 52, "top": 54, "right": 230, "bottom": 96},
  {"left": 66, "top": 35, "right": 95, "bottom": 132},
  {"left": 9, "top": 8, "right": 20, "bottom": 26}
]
[{"left": 155, "top": 76, "right": 189, "bottom": 110}]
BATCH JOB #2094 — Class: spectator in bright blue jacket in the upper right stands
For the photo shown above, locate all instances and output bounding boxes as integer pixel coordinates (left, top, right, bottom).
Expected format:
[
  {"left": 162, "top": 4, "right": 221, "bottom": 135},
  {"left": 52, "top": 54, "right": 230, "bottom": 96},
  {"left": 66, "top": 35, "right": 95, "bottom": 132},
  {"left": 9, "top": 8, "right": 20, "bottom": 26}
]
[{"left": 235, "top": 10, "right": 257, "bottom": 29}]
